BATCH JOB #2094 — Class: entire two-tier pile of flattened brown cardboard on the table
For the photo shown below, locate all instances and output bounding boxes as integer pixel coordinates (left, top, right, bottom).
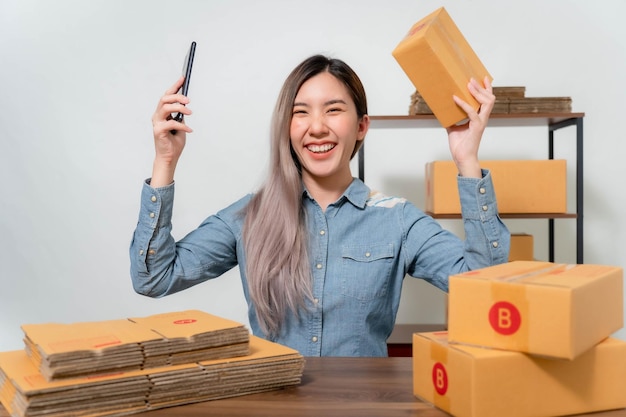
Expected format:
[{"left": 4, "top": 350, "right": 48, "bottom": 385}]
[{"left": 0, "top": 310, "right": 304, "bottom": 417}]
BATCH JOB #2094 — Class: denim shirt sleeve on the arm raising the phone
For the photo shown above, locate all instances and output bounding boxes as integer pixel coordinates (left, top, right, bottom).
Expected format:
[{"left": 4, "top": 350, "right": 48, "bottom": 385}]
[{"left": 129, "top": 180, "right": 237, "bottom": 297}]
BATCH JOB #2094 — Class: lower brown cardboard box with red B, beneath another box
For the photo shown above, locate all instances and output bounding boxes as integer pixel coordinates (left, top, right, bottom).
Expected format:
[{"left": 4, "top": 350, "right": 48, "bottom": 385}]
[{"left": 413, "top": 332, "right": 626, "bottom": 417}]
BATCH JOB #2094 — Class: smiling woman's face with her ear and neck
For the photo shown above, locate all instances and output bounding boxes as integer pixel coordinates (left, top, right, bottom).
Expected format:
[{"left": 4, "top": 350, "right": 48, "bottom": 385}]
[{"left": 290, "top": 72, "right": 369, "bottom": 190}]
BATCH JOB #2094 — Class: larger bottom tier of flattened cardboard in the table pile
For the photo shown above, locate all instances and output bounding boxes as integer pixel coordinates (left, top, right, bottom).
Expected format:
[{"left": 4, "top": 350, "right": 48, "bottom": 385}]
[{"left": 0, "top": 336, "right": 304, "bottom": 417}]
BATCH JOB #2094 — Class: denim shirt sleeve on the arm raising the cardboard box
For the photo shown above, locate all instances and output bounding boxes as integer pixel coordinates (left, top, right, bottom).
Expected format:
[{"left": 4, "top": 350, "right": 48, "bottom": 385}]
[{"left": 404, "top": 170, "right": 510, "bottom": 291}]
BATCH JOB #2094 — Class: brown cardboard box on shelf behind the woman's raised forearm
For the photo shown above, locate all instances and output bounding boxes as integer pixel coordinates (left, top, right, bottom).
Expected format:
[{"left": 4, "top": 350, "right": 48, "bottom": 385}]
[{"left": 425, "top": 159, "right": 567, "bottom": 214}]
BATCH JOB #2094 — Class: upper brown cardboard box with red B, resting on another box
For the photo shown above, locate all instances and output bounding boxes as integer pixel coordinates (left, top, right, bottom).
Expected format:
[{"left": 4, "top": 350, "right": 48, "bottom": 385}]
[{"left": 448, "top": 261, "right": 624, "bottom": 359}]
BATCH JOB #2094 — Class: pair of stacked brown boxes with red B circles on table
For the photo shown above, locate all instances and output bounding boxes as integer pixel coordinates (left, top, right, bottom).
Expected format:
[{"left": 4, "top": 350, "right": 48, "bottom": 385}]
[{"left": 413, "top": 261, "right": 626, "bottom": 417}]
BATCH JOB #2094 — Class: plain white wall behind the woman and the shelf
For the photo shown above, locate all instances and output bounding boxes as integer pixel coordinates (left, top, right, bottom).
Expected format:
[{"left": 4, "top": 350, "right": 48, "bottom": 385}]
[{"left": 0, "top": 0, "right": 626, "bottom": 350}]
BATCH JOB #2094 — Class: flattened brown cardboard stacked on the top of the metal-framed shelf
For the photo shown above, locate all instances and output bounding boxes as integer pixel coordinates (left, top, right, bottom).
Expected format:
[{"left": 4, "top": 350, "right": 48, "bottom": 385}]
[{"left": 409, "top": 87, "right": 572, "bottom": 115}]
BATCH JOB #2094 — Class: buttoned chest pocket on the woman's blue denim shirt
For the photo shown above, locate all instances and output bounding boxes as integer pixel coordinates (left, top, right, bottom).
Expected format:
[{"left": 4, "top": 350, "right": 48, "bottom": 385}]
[{"left": 341, "top": 243, "right": 394, "bottom": 301}]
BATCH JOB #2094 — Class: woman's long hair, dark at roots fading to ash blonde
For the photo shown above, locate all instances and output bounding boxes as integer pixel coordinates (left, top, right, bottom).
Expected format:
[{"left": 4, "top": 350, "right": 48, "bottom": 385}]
[{"left": 243, "top": 55, "right": 367, "bottom": 337}]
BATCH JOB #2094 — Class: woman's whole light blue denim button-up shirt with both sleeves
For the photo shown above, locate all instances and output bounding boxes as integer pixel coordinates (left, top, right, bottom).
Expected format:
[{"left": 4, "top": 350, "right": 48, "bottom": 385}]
[{"left": 130, "top": 171, "right": 510, "bottom": 356}]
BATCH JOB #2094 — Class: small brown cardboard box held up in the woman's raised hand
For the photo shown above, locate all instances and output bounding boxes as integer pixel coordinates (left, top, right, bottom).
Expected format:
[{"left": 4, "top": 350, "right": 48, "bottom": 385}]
[{"left": 392, "top": 7, "right": 491, "bottom": 127}]
